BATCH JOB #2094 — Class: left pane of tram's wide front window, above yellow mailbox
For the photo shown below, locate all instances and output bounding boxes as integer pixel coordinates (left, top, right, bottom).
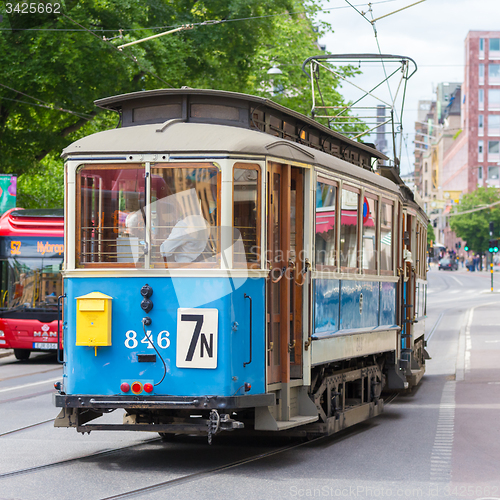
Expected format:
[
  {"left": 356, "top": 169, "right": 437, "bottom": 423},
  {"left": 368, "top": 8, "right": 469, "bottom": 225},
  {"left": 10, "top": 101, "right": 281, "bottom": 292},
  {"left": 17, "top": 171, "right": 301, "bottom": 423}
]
[{"left": 76, "top": 164, "right": 146, "bottom": 267}]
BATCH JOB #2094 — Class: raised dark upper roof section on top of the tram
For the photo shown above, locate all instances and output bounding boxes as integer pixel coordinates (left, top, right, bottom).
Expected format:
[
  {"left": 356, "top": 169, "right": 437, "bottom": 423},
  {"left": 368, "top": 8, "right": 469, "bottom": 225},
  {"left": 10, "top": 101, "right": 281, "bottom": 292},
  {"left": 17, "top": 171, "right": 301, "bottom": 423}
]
[{"left": 91, "top": 88, "right": 388, "bottom": 164}]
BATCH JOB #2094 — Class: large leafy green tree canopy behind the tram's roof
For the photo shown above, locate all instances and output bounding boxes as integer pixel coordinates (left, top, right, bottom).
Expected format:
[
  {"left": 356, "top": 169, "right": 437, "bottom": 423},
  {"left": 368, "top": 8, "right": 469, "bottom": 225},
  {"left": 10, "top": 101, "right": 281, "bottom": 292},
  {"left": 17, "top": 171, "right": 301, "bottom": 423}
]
[{"left": 0, "top": 0, "right": 364, "bottom": 207}]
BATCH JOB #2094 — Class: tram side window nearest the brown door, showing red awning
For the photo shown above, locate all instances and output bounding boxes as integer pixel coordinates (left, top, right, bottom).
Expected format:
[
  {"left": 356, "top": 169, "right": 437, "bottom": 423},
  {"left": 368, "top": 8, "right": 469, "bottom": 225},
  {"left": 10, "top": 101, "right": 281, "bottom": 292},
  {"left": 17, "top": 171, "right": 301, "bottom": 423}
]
[{"left": 316, "top": 181, "right": 337, "bottom": 266}]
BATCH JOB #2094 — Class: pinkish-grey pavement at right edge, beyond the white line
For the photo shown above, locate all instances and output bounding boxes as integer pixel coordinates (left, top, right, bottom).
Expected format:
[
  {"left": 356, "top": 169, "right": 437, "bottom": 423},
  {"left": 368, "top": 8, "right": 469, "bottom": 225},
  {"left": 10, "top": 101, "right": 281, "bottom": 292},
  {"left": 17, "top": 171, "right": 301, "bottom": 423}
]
[{"left": 452, "top": 299, "right": 500, "bottom": 486}]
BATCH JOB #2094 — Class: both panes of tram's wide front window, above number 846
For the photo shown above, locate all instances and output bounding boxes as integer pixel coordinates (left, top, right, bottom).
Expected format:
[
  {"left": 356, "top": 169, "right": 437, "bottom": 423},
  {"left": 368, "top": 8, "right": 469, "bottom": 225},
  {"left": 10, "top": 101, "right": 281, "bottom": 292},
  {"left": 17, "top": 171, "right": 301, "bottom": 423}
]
[{"left": 76, "top": 163, "right": 220, "bottom": 268}]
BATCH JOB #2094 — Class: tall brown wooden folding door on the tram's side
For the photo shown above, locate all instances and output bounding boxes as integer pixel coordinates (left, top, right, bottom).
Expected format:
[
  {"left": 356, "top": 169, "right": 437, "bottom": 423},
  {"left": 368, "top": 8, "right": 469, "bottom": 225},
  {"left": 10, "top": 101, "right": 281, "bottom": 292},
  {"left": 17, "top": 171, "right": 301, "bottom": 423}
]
[{"left": 267, "top": 162, "right": 304, "bottom": 384}]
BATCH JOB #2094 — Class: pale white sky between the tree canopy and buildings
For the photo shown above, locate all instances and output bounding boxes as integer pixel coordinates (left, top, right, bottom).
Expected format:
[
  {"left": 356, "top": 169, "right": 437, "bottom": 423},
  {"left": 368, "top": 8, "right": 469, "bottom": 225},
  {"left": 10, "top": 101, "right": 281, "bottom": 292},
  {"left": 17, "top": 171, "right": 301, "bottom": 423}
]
[{"left": 319, "top": 0, "right": 500, "bottom": 174}]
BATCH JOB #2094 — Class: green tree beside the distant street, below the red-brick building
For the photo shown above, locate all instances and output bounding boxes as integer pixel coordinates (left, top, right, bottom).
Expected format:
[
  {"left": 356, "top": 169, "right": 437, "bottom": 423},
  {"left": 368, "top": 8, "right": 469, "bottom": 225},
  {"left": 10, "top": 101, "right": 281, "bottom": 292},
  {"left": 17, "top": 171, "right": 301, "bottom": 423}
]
[{"left": 450, "top": 187, "right": 500, "bottom": 253}]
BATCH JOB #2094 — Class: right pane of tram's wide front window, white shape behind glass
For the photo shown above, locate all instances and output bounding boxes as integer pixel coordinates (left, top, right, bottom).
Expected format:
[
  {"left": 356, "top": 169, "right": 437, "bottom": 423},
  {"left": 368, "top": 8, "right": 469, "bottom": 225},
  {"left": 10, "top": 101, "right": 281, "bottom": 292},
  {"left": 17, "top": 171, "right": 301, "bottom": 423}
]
[{"left": 151, "top": 163, "right": 220, "bottom": 268}]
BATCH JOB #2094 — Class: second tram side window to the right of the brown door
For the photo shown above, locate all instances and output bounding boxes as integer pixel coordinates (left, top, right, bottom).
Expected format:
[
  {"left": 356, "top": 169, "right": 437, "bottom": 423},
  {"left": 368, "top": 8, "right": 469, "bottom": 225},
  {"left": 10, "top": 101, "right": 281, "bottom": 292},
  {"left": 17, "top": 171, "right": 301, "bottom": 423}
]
[{"left": 340, "top": 189, "right": 359, "bottom": 269}]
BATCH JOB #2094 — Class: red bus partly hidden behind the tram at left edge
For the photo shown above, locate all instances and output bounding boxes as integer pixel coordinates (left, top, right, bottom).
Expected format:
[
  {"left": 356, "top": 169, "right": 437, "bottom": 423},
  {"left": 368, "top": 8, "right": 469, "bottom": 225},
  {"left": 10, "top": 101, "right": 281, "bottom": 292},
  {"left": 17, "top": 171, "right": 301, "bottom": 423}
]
[{"left": 0, "top": 208, "right": 64, "bottom": 360}]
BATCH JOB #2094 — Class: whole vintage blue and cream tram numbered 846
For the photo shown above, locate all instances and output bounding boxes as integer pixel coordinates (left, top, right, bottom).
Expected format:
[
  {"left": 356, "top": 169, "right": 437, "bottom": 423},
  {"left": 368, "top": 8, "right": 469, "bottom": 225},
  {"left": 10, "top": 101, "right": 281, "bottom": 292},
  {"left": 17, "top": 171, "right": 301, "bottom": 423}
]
[{"left": 55, "top": 89, "right": 427, "bottom": 441}]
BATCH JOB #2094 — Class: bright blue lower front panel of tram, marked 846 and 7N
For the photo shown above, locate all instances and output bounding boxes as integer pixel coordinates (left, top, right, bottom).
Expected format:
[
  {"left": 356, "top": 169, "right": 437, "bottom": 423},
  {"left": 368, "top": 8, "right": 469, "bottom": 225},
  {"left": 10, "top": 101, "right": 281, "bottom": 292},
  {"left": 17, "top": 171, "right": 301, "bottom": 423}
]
[{"left": 63, "top": 278, "right": 265, "bottom": 397}]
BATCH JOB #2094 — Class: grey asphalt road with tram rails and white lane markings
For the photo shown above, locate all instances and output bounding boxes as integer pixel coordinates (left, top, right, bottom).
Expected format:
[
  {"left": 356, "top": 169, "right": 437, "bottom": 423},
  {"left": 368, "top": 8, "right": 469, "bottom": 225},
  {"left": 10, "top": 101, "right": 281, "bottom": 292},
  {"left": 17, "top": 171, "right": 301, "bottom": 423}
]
[{"left": 0, "top": 269, "right": 500, "bottom": 500}]
